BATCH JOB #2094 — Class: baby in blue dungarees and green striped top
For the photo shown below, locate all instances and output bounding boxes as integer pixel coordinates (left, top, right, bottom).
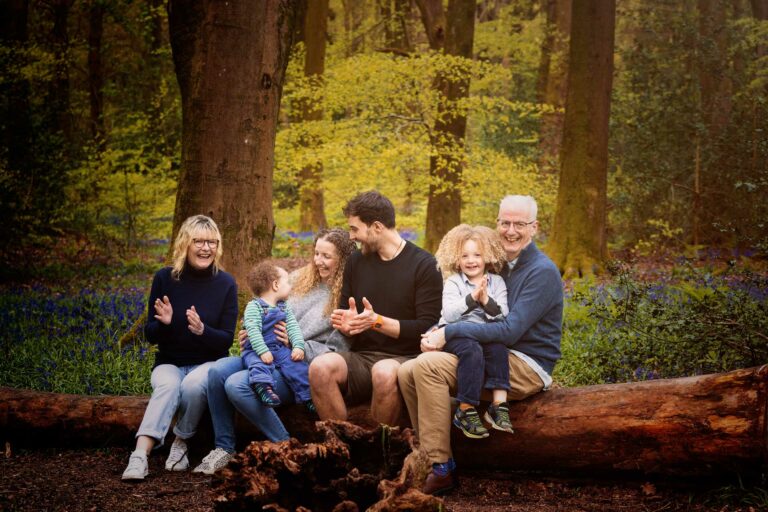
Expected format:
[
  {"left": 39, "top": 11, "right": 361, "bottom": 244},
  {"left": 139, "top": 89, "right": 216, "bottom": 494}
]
[{"left": 242, "top": 261, "right": 315, "bottom": 412}]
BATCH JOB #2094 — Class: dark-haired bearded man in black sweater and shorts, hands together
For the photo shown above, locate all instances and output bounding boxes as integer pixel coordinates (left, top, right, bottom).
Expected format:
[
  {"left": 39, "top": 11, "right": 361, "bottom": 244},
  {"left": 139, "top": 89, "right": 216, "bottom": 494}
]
[{"left": 309, "top": 191, "right": 443, "bottom": 425}]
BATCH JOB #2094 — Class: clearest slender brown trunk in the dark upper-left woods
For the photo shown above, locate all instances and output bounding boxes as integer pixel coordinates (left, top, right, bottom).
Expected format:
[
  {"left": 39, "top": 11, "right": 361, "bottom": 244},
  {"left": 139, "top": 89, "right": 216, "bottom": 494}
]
[{"left": 88, "top": 0, "right": 106, "bottom": 150}]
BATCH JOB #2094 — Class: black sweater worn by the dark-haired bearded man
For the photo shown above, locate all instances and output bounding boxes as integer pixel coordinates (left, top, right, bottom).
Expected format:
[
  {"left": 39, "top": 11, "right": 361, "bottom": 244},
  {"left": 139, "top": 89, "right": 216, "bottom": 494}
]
[{"left": 339, "top": 242, "right": 443, "bottom": 355}]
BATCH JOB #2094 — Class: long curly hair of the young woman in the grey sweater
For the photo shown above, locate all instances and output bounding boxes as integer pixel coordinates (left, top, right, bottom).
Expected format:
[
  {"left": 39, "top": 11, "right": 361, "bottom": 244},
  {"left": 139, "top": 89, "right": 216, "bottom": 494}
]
[{"left": 293, "top": 228, "right": 357, "bottom": 315}]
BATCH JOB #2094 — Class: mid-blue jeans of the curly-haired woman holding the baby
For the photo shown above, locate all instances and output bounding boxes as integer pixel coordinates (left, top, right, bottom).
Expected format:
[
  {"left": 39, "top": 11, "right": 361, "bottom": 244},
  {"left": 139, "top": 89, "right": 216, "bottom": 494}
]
[{"left": 208, "top": 357, "right": 294, "bottom": 453}]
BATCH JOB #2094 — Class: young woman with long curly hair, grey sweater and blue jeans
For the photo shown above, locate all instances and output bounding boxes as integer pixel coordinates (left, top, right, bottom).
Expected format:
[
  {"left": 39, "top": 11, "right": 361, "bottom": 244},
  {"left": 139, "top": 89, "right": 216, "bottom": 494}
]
[{"left": 193, "top": 228, "right": 355, "bottom": 475}]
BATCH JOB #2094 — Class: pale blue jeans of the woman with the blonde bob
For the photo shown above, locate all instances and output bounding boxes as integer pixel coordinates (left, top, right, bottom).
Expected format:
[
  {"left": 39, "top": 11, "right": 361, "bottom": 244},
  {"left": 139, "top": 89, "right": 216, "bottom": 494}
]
[{"left": 136, "top": 362, "right": 213, "bottom": 448}]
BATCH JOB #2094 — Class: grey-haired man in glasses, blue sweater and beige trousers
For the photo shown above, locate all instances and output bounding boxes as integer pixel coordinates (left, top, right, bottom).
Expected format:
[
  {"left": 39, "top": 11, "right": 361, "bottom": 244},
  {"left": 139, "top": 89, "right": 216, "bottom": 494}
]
[{"left": 398, "top": 196, "right": 563, "bottom": 495}]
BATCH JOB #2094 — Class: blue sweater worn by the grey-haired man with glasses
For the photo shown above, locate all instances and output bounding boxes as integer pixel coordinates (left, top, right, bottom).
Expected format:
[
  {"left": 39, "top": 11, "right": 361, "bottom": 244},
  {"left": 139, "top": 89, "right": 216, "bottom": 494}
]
[{"left": 445, "top": 242, "right": 563, "bottom": 375}]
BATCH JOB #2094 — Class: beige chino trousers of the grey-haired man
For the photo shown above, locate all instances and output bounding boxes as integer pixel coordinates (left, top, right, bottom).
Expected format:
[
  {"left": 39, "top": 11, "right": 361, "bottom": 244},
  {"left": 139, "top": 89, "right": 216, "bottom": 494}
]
[{"left": 397, "top": 352, "right": 544, "bottom": 463}]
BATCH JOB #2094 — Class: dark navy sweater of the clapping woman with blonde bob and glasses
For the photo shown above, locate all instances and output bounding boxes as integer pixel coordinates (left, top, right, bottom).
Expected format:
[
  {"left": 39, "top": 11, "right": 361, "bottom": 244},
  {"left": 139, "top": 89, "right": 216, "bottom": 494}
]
[{"left": 144, "top": 266, "right": 237, "bottom": 366}]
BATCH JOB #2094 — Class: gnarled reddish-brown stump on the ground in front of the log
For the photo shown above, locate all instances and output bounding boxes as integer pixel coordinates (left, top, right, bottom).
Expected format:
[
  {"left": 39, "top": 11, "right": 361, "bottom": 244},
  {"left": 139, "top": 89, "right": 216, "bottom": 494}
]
[{"left": 214, "top": 421, "right": 443, "bottom": 512}]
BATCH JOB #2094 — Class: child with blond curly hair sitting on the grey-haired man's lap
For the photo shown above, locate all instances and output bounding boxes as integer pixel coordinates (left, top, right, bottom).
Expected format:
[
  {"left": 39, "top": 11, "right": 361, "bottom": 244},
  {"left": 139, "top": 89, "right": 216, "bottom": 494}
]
[{"left": 435, "top": 224, "right": 513, "bottom": 438}]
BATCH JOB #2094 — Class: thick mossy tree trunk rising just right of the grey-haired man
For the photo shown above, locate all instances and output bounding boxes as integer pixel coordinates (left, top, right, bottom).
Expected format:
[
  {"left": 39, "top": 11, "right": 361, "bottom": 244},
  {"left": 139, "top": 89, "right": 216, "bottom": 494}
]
[{"left": 548, "top": 0, "right": 616, "bottom": 278}]
